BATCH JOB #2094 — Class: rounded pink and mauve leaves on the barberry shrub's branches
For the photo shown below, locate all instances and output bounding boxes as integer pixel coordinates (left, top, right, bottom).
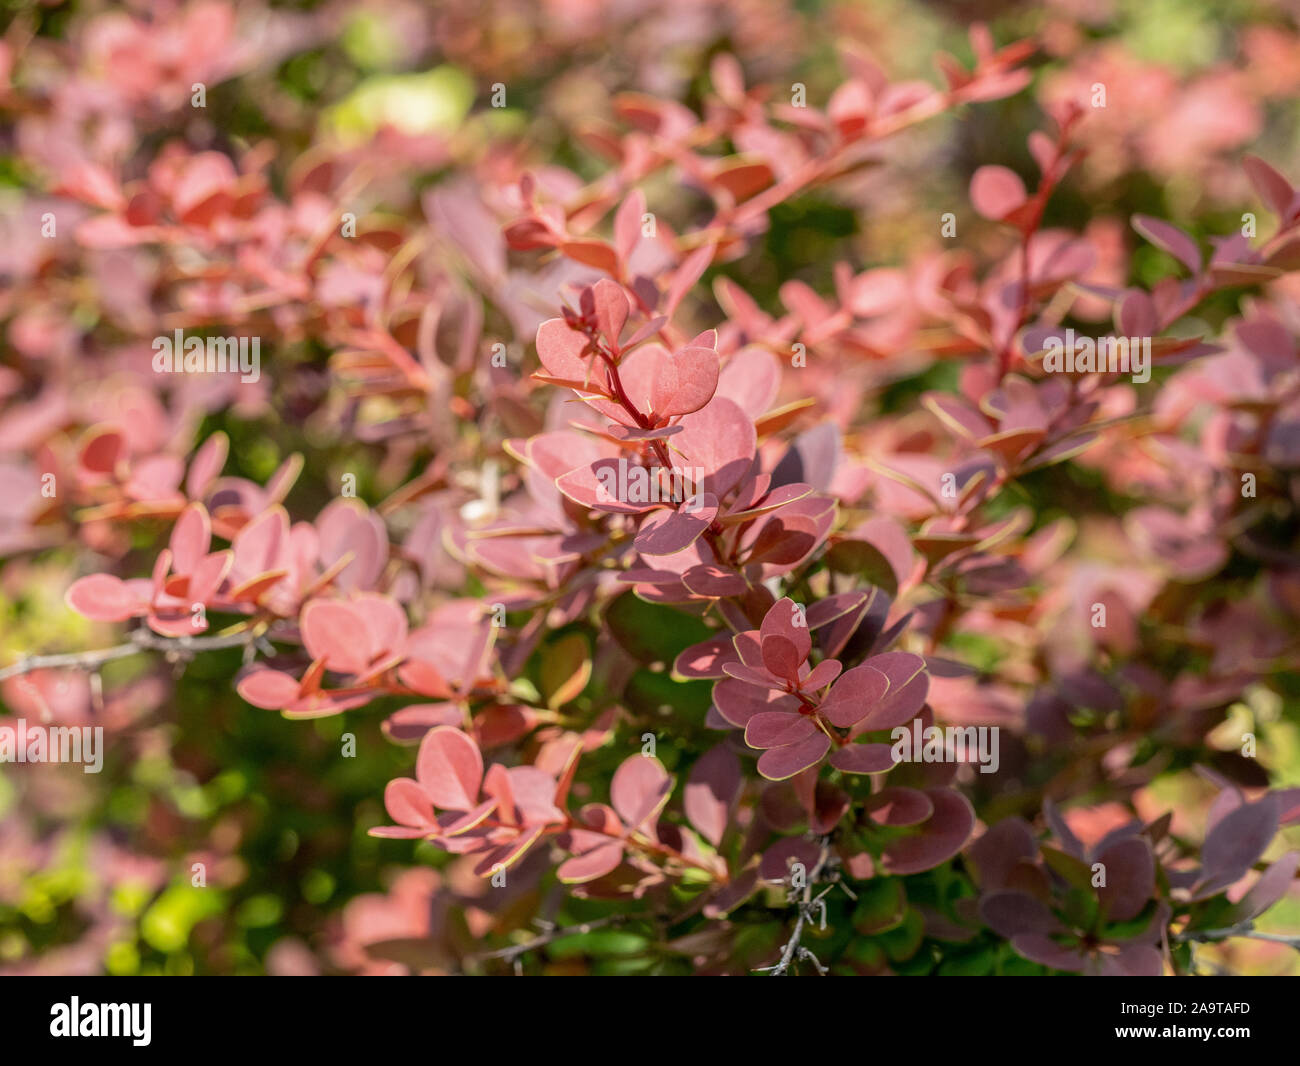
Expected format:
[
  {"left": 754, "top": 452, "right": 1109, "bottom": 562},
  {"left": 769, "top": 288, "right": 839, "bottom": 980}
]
[{"left": 0, "top": 9, "right": 1300, "bottom": 972}]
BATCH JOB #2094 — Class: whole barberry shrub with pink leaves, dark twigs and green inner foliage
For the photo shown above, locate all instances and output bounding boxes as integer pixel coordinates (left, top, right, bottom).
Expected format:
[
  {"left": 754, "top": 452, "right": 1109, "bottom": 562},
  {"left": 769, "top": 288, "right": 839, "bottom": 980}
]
[{"left": 0, "top": 4, "right": 1300, "bottom": 975}]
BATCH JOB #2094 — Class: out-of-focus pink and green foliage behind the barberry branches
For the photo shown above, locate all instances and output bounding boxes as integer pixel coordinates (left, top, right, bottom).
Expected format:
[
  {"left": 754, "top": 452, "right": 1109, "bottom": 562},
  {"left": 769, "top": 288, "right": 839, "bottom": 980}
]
[{"left": 0, "top": 0, "right": 1300, "bottom": 975}]
